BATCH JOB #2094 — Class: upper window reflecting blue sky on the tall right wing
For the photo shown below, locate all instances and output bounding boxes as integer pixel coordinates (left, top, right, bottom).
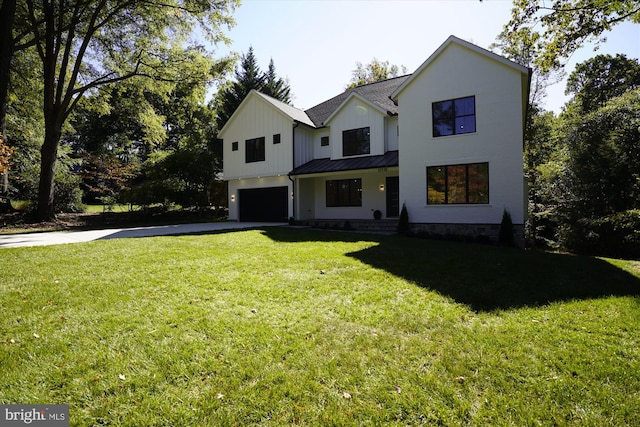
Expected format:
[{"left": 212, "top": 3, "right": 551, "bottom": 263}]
[{"left": 432, "top": 96, "right": 476, "bottom": 137}]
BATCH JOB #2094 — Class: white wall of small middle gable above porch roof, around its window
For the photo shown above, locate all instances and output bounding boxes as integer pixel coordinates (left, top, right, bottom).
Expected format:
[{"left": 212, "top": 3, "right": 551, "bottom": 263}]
[{"left": 328, "top": 97, "right": 385, "bottom": 160}]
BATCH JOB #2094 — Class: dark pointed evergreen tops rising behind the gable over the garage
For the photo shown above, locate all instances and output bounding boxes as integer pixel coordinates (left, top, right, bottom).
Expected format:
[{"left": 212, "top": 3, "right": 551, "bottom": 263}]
[{"left": 214, "top": 47, "right": 291, "bottom": 130}]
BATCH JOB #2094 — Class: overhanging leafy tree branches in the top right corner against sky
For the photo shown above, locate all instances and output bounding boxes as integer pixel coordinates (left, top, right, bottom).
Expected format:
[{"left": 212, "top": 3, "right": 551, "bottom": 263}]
[{"left": 503, "top": 0, "right": 640, "bottom": 72}]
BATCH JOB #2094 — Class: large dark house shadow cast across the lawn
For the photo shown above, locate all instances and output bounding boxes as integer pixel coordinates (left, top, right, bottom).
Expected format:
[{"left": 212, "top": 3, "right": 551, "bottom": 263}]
[{"left": 264, "top": 228, "right": 640, "bottom": 311}]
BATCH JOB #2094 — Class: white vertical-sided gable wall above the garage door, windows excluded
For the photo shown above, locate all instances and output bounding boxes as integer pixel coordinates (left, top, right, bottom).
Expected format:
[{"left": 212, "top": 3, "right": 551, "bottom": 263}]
[{"left": 221, "top": 94, "right": 293, "bottom": 180}]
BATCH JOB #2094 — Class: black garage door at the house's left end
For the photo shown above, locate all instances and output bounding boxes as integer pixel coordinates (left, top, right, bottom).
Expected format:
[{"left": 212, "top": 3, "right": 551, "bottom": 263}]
[{"left": 238, "top": 187, "right": 289, "bottom": 222}]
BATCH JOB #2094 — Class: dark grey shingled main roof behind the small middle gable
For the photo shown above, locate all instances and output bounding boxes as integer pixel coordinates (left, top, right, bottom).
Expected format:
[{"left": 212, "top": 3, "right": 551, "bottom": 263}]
[{"left": 305, "top": 74, "right": 410, "bottom": 127}]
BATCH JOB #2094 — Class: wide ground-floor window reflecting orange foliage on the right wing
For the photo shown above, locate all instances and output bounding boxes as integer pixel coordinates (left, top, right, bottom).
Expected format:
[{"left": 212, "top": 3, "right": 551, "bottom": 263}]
[{"left": 427, "top": 163, "right": 489, "bottom": 205}]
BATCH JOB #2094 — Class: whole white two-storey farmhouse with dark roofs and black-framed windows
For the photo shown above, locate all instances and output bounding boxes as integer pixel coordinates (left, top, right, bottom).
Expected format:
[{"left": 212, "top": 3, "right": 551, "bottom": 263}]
[{"left": 220, "top": 36, "right": 529, "bottom": 246}]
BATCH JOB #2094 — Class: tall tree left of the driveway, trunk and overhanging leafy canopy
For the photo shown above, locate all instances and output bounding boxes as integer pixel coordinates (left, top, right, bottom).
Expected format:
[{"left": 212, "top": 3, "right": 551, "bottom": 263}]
[{"left": 19, "top": 0, "right": 237, "bottom": 219}]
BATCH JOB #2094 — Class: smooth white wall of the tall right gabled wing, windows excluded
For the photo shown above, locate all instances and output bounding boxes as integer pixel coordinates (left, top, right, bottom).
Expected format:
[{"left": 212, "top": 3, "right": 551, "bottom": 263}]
[{"left": 398, "top": 43, "right": 525, "bottom": 224}]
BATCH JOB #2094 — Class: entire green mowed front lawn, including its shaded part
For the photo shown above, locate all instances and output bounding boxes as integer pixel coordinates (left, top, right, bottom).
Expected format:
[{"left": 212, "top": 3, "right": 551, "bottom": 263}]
[{"left": 0, "top": 227, "right": 640, "bottom": 426}]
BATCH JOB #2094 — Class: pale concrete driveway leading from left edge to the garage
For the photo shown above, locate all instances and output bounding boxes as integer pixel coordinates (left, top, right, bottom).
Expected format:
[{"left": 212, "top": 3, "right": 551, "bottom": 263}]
[{"left": 0, "top": 222, "right": 287, "bottom": 249}]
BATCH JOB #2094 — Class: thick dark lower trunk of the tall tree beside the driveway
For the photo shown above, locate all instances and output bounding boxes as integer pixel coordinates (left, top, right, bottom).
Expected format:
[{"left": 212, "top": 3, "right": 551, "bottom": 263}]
[{"left": 36, "top": 117, "right": 62, "bottom": 221}]
